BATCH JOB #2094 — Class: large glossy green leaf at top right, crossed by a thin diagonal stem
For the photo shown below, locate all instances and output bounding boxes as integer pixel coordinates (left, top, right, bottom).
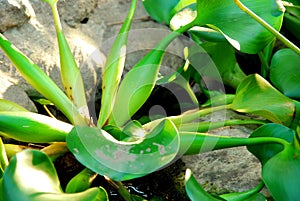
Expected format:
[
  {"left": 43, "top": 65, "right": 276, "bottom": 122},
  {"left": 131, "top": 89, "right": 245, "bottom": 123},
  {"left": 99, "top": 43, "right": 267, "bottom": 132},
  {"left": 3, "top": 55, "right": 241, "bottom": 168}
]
[{"left": 173, "top": 0, "right": 283, "bottom": 54}]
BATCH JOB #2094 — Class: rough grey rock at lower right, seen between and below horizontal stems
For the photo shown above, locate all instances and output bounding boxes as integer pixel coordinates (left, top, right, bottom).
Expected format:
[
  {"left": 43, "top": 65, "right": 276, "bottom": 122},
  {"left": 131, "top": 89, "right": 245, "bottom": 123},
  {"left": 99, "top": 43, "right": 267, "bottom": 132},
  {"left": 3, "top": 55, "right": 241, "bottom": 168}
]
[{"left": 182, "top": 111, "right": 270, "bottom": 196}]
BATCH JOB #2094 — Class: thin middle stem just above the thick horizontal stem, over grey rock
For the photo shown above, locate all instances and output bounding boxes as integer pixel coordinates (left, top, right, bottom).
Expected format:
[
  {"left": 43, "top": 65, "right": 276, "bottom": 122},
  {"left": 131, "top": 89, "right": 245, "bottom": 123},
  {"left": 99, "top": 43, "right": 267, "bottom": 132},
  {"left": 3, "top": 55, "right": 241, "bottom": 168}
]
[{"left": 178, "top": 119, "right": 267, "bottom": 132}]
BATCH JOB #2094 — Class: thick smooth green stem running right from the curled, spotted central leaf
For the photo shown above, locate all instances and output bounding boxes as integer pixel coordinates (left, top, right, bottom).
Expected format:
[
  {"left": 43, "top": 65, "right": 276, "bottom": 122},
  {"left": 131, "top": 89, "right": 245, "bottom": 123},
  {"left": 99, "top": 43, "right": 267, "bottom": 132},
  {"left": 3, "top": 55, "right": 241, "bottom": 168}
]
[{"left": 178, "top": 132, "right": 290, "bottom": 156}]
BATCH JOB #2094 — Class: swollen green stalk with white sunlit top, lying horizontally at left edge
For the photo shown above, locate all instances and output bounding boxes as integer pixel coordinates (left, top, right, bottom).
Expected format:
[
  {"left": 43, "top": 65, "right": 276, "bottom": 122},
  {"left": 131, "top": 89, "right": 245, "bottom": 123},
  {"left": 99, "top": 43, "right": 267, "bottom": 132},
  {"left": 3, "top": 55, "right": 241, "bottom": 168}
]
[{"left": 0, "top": 112, "right": 73, "bottom": 143}]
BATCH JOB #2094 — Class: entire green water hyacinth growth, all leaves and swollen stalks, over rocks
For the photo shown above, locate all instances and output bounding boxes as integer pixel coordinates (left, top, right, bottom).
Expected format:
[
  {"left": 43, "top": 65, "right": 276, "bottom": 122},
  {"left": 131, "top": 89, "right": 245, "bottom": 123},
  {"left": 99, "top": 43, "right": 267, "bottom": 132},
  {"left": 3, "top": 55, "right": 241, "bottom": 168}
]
[{"left": 0, "top": 0, "right": 300, "bottom": 201}]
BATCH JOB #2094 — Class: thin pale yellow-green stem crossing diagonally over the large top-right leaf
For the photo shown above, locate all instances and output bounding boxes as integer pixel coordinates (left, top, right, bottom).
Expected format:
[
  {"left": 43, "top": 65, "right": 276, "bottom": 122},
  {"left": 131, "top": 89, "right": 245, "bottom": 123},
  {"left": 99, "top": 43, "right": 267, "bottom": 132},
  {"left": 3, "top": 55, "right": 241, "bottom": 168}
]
[{"left": 234, "top": 0, "right": 300, "bottom": 55}]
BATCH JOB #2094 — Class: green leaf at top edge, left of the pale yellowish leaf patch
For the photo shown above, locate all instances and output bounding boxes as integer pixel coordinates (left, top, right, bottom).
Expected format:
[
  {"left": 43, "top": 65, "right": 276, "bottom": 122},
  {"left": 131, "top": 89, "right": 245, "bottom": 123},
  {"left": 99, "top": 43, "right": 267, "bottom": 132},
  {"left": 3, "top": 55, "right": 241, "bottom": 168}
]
[{"left": 143, "top": 0, "right": 180, "bottom": 24}]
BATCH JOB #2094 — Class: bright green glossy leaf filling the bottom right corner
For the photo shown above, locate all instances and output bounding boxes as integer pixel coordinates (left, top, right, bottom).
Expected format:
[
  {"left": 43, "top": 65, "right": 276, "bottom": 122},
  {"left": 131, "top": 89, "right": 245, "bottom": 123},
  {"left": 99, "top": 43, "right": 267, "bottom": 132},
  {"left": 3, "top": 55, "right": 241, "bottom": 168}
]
[{"left": 262, "top": 146, "right": 300, "bottom": 201}]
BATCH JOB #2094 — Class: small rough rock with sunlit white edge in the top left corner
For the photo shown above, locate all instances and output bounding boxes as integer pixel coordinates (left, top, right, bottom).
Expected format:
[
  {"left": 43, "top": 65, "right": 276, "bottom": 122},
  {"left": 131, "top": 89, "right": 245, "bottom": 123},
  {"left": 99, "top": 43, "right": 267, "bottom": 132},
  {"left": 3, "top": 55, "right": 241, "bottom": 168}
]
[{"left": 0, "top": 0, "right": 32, "bottom": 32}]
